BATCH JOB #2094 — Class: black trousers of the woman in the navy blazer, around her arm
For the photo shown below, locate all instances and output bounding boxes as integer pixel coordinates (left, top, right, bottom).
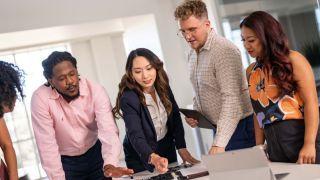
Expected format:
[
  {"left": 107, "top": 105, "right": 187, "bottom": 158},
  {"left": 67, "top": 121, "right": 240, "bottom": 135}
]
[{"left": 124, "top": 134, "right": 177, "bottom": 173}]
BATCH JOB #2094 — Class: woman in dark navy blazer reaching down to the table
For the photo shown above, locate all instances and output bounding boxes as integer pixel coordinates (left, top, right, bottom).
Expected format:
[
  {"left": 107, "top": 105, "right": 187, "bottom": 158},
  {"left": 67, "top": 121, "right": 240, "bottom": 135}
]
[{"left": 113, "top": 48, "right": 199, "bottom": 173}]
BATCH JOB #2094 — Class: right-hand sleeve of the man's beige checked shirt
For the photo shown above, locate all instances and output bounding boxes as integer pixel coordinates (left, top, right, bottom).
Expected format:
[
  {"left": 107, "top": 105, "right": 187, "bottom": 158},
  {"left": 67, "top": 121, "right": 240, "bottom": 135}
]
[{"left": 213, "top": 49, "right": 243, "bottom": 147}]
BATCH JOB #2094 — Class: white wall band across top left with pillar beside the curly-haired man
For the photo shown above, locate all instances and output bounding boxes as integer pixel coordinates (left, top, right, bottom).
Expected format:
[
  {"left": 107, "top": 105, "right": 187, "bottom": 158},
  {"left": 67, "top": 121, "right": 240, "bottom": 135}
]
[{"left": 0, "top": 0, "right": 192, "bottom": 106}]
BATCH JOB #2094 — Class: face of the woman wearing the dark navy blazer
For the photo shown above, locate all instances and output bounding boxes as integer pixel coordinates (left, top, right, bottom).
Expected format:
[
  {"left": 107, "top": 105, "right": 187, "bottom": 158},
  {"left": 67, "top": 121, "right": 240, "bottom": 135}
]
[{"left": 132, "top": 56, "right": 157, "bottom": 92}]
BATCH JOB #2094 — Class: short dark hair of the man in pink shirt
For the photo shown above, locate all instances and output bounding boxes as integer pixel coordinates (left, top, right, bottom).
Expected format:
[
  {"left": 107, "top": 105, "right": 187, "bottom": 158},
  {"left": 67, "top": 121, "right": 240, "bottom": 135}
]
[{"left": 42, "top": 51, "right": 77, "bottom": 85}]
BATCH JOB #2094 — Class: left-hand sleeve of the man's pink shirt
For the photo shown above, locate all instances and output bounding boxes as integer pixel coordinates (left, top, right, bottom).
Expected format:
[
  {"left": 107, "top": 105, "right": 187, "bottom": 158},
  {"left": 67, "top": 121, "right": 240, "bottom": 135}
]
[{"left": 31, "top": 93, "right": 65, "bottom": 180}]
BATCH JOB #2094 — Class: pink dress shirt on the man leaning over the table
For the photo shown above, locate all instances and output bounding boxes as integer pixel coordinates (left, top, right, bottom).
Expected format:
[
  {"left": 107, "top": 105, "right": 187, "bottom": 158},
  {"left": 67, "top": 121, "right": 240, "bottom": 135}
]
[{"left": 31, "top": 78, "right": 121, "bottom": 180}]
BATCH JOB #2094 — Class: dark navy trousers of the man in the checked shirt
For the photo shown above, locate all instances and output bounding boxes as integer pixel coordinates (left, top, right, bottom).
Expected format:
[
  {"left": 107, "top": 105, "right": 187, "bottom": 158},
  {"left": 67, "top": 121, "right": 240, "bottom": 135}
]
[{"left": 213, "top": 115, "right": 256, "bottom": 151}]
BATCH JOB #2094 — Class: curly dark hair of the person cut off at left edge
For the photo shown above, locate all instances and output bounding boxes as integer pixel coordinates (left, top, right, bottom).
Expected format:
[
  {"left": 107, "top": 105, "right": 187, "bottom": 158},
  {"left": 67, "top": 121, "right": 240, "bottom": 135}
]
[{"left": 0, "top": 61, "right": 24, "bottom": 118}]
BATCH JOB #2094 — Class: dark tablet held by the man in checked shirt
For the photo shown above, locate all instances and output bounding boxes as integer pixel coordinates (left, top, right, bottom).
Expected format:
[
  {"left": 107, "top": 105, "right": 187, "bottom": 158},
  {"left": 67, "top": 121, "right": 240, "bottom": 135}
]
[{"left": 179, "top": 108, "right": 217, "bottom": 129}]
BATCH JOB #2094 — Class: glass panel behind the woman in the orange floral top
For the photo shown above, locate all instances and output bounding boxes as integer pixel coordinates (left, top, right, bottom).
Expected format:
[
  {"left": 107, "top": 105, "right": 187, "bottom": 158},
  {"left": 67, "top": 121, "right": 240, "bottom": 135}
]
[{"left": 213, "top": 0, "right": 320, "bottom": 67}]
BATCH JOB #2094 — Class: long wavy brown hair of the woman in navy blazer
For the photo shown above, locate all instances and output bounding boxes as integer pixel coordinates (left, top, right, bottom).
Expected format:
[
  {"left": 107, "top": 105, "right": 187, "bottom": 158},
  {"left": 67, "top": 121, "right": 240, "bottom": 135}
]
[{"left": 112, "top": 48, "right": 172, "bottom": 118}]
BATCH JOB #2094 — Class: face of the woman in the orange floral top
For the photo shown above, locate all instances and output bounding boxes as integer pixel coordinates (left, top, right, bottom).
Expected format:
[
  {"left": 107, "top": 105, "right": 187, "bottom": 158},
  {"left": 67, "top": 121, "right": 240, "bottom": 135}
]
[{"left": 241, "top": 26, "right": 262, "bottom": 58}]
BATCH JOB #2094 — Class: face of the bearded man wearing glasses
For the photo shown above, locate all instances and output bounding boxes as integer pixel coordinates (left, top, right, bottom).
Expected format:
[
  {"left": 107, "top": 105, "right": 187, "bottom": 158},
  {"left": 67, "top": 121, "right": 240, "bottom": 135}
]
[{"left": 179, "top": 15, "right": 211, "bottom": 50}]
